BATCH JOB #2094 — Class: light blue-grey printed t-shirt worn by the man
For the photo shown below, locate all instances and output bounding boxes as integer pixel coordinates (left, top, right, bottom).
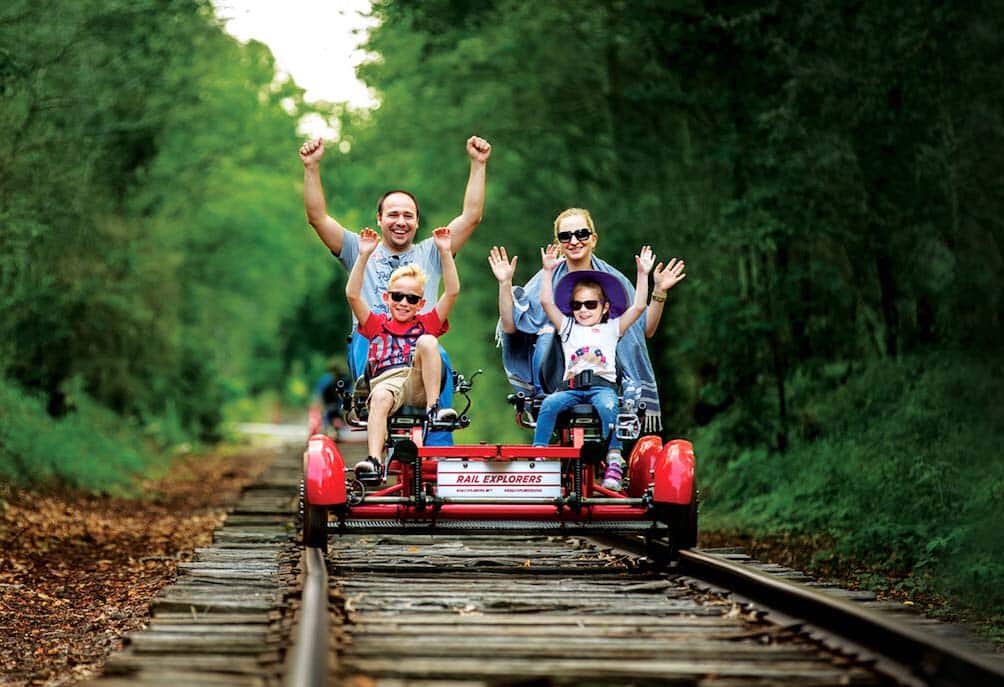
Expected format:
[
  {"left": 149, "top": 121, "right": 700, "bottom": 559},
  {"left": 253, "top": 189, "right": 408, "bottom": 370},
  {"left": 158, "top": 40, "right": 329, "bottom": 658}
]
[{"left": 335, "top": 231, "right": 443, "bottom": 328}]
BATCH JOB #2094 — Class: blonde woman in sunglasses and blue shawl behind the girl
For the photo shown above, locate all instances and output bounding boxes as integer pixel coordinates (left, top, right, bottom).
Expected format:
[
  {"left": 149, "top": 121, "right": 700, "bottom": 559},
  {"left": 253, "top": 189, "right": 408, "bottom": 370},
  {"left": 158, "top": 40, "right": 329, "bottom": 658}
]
[{"left": 489, "top": 208, "right": 687, "bottom": 434}]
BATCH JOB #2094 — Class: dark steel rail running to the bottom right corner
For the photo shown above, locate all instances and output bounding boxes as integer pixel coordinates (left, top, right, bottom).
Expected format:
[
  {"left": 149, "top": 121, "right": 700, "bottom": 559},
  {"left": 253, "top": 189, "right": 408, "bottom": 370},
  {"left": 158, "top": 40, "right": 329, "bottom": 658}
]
[{"left": 590, "top": 534, "right": 1004, "bottom": 687}]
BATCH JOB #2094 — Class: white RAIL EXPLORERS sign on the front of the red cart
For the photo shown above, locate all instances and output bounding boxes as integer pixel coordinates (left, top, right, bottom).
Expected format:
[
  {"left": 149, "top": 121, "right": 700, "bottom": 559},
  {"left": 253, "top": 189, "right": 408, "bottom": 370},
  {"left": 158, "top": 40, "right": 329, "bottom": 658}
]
[{"left": 437, "top": 459, "right": 561, "bottom": 500}]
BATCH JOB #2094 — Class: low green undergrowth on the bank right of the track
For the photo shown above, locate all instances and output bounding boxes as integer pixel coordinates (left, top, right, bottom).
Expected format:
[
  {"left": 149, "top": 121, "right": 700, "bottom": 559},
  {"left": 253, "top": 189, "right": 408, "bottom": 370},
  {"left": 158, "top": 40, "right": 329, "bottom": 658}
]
[{"left": 696, "top": 352, "right": 1004, "bottom": 612}]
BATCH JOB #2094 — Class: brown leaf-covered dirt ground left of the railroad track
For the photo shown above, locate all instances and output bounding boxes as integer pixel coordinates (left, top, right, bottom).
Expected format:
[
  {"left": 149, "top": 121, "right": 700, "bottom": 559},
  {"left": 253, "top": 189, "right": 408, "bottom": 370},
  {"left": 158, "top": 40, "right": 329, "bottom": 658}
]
[{"left": 0, "top": 449, "right": 275, "bottom": 686}]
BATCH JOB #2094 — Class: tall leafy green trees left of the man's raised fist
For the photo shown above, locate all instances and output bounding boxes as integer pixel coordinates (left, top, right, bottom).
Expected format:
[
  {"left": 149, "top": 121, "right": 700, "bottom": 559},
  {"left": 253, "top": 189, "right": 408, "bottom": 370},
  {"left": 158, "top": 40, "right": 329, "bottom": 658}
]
[{"left": 0, "top": 0, "right": 324, "bottom": 484}]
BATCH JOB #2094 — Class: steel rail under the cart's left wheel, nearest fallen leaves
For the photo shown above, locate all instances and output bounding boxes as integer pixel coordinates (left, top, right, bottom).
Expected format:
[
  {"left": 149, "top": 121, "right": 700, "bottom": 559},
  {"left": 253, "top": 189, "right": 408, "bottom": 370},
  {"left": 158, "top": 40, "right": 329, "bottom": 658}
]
[{"left": 283, "top": 546, "right": 329, "bottom": 687}]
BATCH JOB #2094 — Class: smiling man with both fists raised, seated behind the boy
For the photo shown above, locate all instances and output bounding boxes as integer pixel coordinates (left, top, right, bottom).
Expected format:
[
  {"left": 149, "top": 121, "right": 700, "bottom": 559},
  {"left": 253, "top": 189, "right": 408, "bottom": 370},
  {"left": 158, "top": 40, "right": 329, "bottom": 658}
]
[{"left": 299, "top": 136, "right": 492, "bottom": 445}]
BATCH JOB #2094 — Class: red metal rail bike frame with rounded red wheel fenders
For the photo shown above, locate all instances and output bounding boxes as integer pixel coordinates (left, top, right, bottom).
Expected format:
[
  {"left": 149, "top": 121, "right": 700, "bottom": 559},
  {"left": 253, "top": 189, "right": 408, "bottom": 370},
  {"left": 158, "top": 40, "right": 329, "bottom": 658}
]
[{"left": 301, "top": 369, "right": 697, "bottom": 549}]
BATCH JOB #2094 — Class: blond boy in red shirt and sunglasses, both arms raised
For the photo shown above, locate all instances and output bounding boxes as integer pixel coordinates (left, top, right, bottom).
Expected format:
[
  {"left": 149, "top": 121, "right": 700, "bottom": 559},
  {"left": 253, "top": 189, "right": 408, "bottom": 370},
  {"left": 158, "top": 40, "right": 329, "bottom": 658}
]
[{"left": 345, "top": 227, "right": 460, "bottom": 482}]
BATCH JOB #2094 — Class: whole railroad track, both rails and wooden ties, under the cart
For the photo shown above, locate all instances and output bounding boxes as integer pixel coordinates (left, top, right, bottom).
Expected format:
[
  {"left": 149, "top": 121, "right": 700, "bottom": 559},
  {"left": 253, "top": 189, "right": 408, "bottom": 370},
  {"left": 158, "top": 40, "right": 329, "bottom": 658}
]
[{"left": 80, "top": 441, "right": 1004, "bottom": 687}]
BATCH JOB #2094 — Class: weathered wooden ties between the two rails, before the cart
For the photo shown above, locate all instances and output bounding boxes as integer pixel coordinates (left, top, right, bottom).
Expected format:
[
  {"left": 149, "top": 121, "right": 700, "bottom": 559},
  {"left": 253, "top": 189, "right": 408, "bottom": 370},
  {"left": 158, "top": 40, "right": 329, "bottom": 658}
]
[{"left": 321, "top": 536, "right": 881, "bottom": 685}]
